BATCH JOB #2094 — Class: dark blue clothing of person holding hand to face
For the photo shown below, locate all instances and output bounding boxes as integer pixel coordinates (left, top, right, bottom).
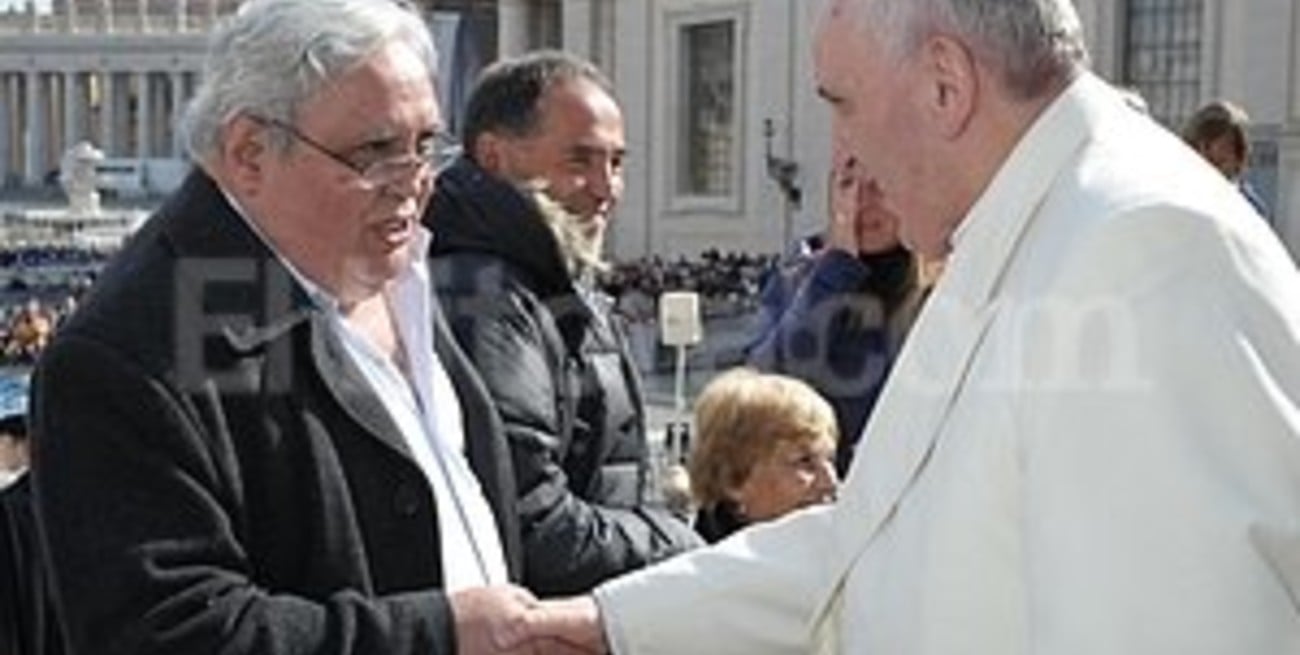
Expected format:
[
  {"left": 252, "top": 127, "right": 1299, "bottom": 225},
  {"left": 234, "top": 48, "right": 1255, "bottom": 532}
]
[{"left": 748, "top": 248, "right": 913, "bottom": 476}]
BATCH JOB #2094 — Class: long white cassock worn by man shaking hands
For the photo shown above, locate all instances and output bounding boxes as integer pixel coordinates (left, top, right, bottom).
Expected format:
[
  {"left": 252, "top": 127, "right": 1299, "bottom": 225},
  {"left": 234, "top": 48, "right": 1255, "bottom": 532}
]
[{"left": 597, "top": 74, "right": 1300, "bottom": 655}]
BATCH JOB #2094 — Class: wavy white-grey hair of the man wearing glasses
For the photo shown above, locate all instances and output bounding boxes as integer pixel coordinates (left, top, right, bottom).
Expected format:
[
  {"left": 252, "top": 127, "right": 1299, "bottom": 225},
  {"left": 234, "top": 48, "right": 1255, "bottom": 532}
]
[{"left": 181, "top": 0, "right": 437, "bottom": 161}]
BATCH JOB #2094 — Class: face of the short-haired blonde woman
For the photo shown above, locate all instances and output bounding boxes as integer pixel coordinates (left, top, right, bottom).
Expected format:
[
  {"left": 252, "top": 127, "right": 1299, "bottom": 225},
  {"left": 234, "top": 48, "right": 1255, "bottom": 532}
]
[{"left": 731, "top": 434, "right": 840, "bottom": 522}]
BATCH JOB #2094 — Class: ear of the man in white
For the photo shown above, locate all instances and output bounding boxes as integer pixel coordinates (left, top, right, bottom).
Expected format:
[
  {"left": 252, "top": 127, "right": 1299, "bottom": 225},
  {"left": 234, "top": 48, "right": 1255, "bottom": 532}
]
[{"left": 922, "top": 35, "right": 982, "bottom": 139}]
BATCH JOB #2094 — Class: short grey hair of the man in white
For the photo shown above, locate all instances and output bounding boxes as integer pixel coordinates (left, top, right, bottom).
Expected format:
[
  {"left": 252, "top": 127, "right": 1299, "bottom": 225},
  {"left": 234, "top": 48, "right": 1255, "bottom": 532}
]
[{"left": 859, "top": 0, "right": 1088, "bottom": 99}]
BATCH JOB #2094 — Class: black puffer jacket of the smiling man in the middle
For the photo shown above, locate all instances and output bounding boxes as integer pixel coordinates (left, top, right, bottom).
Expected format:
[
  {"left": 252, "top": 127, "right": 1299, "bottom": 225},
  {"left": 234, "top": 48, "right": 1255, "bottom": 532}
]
[{"left": 425, "top": 159, "right": 699, "bottom": 595}]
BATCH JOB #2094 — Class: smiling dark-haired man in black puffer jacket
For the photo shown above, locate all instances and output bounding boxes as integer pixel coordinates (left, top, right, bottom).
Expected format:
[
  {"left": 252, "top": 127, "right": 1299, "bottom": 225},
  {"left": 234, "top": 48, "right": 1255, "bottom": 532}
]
[{"left": 426, "top": 52, "right": 699, "bottom": 595}]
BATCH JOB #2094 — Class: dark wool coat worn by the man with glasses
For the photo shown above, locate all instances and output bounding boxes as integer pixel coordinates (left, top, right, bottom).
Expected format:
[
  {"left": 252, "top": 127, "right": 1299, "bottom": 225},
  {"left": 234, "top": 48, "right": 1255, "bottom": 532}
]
[{"left": 31, "top": 173, "right": 519, "bottom": 655}]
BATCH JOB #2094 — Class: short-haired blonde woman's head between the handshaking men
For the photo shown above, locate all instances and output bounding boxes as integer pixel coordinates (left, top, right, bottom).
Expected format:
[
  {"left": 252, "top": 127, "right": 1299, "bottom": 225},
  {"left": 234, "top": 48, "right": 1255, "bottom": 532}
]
[{"left": 690, "top": 368, "right": 839, "bottom": 542}]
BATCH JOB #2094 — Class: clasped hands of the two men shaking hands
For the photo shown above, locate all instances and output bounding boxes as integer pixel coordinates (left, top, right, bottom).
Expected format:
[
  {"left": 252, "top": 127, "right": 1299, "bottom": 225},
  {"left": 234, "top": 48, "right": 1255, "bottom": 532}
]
[{"left": 449, "top": 585, "right": 608, "bottom": 655}]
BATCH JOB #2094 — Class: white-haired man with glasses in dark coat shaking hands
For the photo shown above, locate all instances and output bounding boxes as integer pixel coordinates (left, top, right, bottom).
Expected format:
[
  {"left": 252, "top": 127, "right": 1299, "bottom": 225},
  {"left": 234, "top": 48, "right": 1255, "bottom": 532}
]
[{"left": 31, "top": 0, "right": 559, "bottom": 655}]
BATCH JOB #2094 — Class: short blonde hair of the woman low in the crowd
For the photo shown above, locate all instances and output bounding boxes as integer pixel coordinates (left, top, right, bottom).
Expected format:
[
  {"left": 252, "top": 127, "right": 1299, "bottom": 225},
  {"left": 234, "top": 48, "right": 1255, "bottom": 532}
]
[{"left": 689, "top": 368, "right": 840, "bottom": 508}]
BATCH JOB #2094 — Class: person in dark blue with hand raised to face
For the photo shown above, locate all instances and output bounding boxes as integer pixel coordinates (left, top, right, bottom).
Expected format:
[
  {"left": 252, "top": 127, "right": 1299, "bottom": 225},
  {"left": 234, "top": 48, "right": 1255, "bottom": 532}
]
[{"left": 746, "top": 144, "right": 933, "bottom": 476}]
